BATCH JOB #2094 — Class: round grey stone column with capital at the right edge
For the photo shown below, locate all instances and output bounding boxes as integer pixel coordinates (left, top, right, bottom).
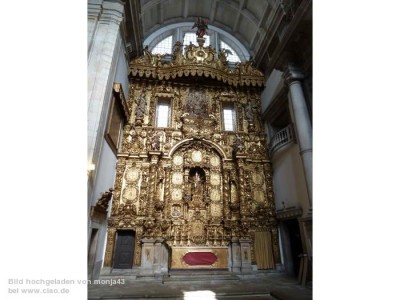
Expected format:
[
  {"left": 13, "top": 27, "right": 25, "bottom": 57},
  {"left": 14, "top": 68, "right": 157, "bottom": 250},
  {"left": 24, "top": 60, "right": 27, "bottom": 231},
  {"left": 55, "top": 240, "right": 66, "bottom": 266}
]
[{"left": 282, "top": 64, "right": 312, "bottom": 210}]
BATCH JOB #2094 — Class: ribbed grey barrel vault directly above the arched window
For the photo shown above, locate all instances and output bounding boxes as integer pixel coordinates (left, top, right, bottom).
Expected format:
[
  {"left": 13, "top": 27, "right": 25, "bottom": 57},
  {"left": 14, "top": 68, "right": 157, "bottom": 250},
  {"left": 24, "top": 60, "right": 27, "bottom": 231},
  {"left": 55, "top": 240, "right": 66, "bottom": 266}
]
[{"left": 140, "top": 0, "right": 278, "bottom": 53}]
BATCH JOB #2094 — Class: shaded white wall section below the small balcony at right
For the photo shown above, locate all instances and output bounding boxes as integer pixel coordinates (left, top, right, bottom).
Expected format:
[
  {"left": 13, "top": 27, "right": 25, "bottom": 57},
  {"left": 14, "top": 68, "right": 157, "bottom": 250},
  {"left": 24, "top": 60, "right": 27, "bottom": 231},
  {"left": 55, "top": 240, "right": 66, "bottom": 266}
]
[{"left": 272, "top": 143, "right": 309, "bottom": 213}]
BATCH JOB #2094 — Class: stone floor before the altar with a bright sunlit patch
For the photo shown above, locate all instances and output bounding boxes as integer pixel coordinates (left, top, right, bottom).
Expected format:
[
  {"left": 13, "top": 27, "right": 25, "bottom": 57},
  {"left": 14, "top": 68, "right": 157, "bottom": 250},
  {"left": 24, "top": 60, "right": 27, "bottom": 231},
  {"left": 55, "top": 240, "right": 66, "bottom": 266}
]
[{"left": 88, "top": 273, "right": 312, "bottom": 300}]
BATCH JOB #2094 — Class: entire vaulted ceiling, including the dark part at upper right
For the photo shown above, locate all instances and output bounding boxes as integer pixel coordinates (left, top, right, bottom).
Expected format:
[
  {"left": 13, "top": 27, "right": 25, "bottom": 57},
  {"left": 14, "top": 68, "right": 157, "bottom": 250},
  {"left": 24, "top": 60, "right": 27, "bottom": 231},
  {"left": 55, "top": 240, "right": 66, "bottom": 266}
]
[{"left": 126, "top": 0, "right": 312, "bottom": 74}]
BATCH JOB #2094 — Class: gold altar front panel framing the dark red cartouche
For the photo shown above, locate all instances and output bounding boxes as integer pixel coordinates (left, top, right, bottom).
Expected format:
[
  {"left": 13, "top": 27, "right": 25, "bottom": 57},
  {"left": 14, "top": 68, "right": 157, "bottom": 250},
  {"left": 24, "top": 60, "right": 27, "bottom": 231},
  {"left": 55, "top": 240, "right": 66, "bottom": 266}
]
[{"left": 171, "top": 247, "right": 228, "bottom": 269}]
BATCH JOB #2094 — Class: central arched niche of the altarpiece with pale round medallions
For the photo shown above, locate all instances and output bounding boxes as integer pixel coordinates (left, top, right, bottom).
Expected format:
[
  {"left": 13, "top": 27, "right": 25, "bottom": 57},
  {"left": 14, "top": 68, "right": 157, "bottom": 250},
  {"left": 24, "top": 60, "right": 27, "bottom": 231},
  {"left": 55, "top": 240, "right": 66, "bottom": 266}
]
[{"left": 166, "top": 140, "right": 224, "bottom": 246}]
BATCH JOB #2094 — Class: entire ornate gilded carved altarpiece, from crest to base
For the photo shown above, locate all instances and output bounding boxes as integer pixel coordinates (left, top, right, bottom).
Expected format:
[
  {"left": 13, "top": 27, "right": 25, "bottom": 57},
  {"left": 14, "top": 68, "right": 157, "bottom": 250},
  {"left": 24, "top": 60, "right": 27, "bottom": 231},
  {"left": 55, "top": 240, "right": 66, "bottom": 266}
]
[{"left": 105, "top": 38, "right": 280, "bottom": 268}]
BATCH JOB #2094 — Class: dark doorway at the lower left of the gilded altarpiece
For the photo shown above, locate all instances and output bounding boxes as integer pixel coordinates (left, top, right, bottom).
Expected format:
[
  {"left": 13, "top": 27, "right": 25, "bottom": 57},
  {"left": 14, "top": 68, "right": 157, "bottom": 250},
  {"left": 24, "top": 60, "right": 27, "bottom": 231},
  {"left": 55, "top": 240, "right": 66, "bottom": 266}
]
[{"left": 113, "top": 230, "right": 135, "bottom": 269}]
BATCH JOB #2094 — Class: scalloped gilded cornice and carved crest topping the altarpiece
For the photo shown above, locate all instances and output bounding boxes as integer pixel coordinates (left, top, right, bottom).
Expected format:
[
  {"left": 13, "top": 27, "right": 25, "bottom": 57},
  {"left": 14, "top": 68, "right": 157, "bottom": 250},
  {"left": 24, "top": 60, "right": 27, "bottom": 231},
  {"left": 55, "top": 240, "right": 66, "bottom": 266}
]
[{"left": 129, "top": 42, "right": 265, "bottom": 87}]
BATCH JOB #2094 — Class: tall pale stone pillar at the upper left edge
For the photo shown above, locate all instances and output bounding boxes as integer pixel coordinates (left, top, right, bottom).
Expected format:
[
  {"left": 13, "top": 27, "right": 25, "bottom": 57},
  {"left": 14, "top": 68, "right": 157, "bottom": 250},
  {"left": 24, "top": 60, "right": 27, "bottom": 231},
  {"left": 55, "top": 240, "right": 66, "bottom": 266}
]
[{"left": 87, "top": 0, "right": 124, "bottom": 172}]
